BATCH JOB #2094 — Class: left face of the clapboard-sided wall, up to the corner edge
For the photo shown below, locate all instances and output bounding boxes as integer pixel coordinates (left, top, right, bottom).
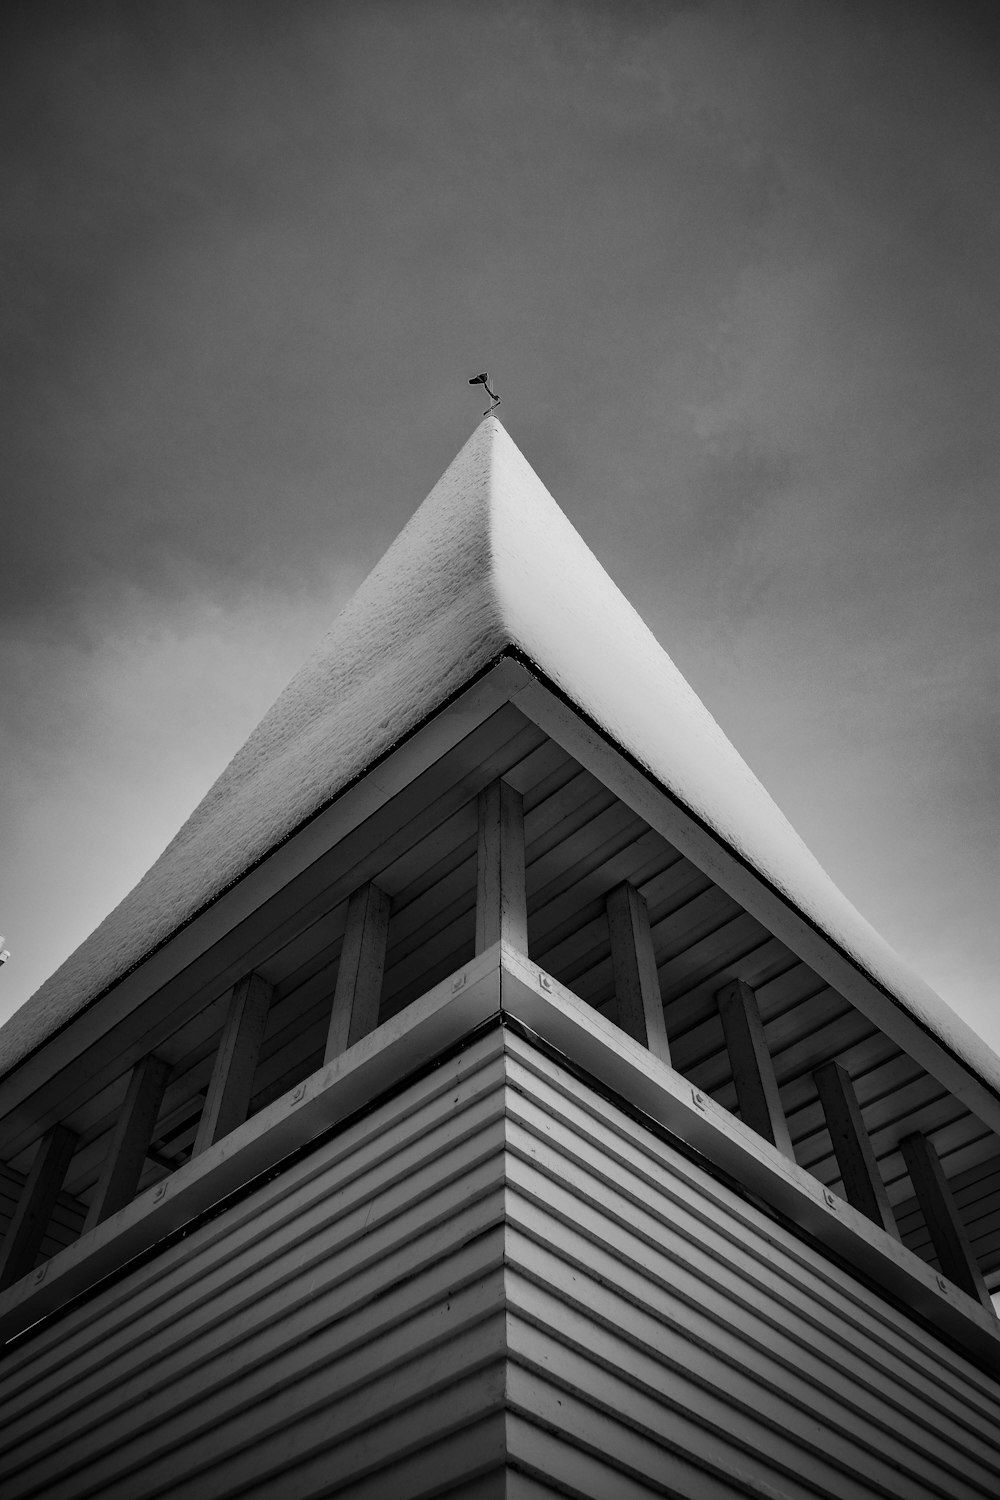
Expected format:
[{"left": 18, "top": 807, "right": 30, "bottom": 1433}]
[{"left": 0, "top": 1034, "right": 505, "bottom": 1500}]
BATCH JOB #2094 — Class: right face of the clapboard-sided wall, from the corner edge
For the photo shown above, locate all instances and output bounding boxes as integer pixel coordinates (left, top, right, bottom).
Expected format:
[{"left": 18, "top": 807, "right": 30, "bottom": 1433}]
[{"left": 507, "top": 1040, "right": 1000, "bottom": 1500}]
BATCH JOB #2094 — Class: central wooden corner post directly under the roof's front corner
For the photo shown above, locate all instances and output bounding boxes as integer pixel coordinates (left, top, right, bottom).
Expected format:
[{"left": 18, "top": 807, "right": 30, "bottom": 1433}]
[{"left": 475, "top": 780, "right": 528, "bottom": 954}]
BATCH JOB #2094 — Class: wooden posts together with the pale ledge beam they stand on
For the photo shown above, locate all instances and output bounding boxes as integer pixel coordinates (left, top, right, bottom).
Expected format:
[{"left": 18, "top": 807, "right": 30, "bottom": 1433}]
[{"left": 0, "top": 779, "right": 1000, "bottom": 1368}]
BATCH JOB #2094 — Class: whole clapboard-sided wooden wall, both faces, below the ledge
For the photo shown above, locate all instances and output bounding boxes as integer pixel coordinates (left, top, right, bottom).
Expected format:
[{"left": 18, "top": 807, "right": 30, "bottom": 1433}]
[{"left": 0, "top": 1032, "right": 1000, "bottom": 1500}]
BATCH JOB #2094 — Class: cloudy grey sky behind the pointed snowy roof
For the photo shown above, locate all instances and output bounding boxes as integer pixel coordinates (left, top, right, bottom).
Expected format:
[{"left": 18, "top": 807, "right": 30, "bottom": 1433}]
[{"left": 0, "top": 0, "right": 1000, "bottom": 1049}]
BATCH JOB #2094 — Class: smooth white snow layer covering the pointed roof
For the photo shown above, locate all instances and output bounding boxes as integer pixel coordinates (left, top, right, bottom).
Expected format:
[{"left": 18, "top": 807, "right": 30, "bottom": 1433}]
[{"left": 0, "top": 417, "right": 1000, "bottom": 1089}]
